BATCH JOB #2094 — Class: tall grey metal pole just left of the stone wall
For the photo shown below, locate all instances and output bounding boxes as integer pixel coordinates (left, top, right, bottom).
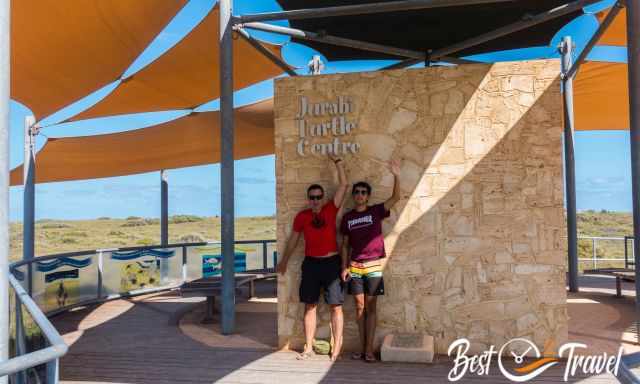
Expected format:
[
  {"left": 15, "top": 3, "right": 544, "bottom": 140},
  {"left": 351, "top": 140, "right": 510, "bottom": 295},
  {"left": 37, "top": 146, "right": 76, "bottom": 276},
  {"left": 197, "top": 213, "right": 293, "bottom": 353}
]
[{"left": 219, "top": 0, "right": 235, "bottom": 335}]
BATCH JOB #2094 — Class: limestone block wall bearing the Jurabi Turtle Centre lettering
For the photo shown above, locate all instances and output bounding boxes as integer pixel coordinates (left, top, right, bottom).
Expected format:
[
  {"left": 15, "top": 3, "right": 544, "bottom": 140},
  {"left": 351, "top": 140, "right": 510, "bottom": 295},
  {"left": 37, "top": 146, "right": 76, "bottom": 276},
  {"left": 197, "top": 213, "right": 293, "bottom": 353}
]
[{"left": 275, "top": 61, "right": 567, "bottom": 353}]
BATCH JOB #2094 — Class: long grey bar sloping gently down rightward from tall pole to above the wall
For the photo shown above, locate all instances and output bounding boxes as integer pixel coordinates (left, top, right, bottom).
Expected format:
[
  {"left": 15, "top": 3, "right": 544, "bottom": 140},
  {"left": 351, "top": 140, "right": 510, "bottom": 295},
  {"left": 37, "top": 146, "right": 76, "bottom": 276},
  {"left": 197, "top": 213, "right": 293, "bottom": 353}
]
[{"left": 238, "top": 22, "right": 426, "bottom": 60}]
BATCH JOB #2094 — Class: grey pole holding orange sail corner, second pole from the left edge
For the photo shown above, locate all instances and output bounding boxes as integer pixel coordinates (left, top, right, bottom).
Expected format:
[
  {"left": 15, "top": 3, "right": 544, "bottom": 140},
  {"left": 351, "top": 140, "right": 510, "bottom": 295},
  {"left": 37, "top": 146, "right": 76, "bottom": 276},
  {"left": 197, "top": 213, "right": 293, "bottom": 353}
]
[{"left": 22, "top": 116, "right": 36, "bottom": 278}]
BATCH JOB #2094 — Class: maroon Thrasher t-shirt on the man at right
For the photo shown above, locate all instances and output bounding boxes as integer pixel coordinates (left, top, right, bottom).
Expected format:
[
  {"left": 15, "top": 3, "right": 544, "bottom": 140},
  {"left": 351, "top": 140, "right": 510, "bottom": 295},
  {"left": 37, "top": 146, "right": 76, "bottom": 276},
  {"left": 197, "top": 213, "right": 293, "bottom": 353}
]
[{"left": 340, "top": 203, "right": 390, "bottom": 261}]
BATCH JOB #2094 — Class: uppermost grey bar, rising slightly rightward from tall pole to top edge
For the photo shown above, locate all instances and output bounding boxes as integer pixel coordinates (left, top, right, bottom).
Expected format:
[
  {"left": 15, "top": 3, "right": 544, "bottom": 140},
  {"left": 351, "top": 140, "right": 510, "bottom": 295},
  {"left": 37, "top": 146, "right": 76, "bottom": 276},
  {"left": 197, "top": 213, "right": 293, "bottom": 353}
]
[{"left": 236, "top": 0, "right": 514, "bottom": 23}]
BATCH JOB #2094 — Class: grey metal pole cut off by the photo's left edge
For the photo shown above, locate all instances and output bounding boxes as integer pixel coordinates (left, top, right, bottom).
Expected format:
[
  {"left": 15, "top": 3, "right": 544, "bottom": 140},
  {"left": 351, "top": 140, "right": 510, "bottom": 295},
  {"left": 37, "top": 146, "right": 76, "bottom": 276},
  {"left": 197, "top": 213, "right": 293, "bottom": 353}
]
[{"left": 0, "top": 0, "right": 11, "bottom": 384}]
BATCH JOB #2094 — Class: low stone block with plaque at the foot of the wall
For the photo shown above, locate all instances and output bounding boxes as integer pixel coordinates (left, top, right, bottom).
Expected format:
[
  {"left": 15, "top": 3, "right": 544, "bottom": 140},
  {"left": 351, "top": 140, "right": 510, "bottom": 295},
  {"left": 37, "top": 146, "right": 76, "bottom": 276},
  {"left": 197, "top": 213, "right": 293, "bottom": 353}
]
[{"left": 380, "top": 333, "right": 434, "bottom": 363}]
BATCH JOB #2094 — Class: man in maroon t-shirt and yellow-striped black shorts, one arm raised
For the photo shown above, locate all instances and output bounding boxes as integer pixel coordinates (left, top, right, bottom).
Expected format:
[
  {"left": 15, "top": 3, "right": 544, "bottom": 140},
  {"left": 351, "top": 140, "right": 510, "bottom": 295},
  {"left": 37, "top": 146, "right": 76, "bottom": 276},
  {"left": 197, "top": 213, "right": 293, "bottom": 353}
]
[{"left": 340, "top": 161, "right": 400, "bottom": 362}]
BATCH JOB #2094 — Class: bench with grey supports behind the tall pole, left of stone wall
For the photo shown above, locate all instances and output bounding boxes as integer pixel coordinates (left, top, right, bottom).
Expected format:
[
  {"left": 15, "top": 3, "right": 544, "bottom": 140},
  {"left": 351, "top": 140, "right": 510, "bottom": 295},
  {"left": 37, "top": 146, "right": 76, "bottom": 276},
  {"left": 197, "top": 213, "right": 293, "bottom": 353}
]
[{"left": 179, "top": 272, "right": 277, "bottom": 324}]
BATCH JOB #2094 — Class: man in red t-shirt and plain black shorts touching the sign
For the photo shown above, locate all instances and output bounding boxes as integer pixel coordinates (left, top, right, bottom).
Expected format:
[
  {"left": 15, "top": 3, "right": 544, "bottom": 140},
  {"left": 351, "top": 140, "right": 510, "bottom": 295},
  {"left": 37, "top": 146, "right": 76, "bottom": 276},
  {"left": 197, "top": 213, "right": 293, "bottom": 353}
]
[{"left": 277, "top": 156, "right": 349, "bottom": 361}]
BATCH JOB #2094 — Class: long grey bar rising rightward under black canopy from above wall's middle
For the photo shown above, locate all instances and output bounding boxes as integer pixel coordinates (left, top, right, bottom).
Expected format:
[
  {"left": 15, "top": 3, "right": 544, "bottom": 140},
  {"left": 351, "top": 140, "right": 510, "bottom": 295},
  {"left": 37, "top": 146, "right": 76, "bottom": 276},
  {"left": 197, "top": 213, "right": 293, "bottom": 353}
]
[{"left": 431, "top": 0, "right": 600, "bottom": 61}]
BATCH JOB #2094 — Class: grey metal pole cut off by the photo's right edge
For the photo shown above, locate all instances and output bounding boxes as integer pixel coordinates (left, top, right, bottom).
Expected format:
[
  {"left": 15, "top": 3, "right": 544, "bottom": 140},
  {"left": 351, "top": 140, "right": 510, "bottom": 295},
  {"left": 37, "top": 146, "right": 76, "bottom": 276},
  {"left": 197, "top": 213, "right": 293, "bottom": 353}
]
[{"left": 627, "top": 0, "right": 640, "bottom": 316}]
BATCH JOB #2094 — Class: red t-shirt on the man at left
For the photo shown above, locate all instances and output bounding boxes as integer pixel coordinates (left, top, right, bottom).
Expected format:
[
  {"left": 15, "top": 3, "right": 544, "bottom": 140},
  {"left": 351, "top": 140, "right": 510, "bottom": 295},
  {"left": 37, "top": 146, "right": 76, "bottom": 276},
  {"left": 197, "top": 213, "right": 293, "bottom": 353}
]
[{"left": 293, "top": 200, "right": 338, "bottom": 257}]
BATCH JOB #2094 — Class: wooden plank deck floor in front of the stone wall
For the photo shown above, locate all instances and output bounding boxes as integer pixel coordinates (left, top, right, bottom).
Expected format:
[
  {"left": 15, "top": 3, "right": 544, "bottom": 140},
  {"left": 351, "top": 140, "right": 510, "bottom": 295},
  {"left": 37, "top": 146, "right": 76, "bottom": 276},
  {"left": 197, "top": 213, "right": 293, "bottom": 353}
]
[{"left": 52, "top": 280, "right": 617, "bottom": 384}]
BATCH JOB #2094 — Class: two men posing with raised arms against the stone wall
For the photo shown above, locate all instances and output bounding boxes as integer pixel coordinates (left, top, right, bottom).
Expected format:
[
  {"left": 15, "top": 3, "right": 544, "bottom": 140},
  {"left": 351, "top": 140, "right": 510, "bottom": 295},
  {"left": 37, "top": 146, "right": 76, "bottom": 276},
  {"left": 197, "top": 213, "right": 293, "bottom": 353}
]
[{"left": 277, "top": 157, "right": 400, "bottom": 362}]
